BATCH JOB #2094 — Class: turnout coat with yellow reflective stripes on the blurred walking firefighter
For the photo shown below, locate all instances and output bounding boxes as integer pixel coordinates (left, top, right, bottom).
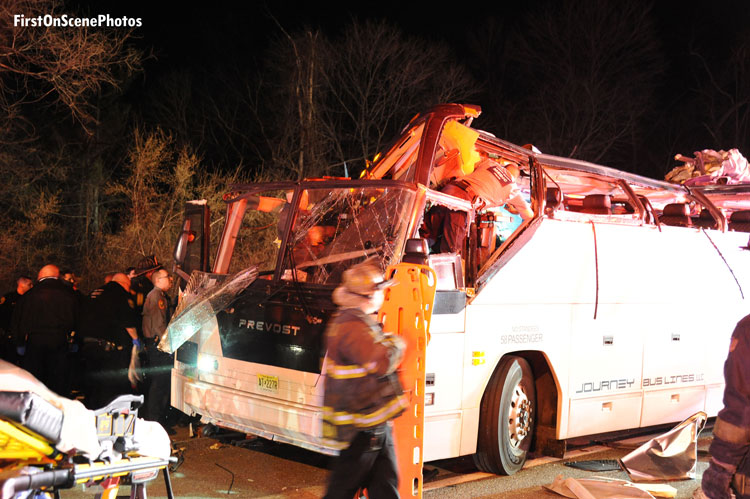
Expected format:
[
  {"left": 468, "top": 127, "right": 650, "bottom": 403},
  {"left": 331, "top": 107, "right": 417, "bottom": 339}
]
[{"left": 323, "top": 308, "right": 407, "bottom": 448}]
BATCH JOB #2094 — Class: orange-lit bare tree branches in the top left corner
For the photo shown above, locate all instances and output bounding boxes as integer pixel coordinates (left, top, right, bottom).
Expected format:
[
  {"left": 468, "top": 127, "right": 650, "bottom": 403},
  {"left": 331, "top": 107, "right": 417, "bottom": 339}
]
[{"left": 0, "top": 0, "right": 140, "bottom": 141}]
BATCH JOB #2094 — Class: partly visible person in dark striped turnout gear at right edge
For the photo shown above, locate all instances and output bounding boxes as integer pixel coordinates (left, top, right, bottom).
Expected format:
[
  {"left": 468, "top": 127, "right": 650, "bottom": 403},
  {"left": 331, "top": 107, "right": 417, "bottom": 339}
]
[{"left": 694, "top": 315, "right": 750, "bottom": 499}]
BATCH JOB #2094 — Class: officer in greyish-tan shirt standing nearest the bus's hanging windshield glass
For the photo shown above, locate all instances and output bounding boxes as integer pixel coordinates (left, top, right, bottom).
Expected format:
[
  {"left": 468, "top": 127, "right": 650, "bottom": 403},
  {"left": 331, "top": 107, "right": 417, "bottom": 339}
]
[{"left": 143, "top": 269, "right": 174, "bottom": 431}]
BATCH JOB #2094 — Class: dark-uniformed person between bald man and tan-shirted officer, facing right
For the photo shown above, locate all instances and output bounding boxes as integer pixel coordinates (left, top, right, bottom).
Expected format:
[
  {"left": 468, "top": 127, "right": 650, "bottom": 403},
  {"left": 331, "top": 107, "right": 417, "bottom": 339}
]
[{"left": 80, "top": 273, "right": 142, "bottom": 409}]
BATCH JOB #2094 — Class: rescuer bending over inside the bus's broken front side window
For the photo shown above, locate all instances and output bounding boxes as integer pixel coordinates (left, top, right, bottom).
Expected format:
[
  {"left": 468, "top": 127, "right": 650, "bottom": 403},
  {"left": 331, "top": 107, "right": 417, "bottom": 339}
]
[{"left": 421, "top": 157, "right": 534, "bottom": 253}]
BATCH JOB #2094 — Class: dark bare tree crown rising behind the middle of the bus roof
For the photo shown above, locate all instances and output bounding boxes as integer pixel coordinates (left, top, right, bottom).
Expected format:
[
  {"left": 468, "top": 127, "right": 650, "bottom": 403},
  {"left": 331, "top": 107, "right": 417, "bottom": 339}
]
[{"left": 508, "top": 0, "right": 664, "bottom": 167}]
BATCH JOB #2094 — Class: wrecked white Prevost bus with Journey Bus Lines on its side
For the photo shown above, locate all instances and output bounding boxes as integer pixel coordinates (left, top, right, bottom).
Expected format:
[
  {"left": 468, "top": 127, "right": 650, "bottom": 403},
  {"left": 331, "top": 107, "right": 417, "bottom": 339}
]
[{"left": 170, "top": 104, "right": 750, "bottom": 474}]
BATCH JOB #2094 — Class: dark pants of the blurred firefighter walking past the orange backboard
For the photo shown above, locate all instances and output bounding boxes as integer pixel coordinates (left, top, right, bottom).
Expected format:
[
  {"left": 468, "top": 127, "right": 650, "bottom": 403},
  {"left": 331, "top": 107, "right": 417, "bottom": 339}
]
[{"left": 325, "top": 424, "right": 399, "bottom": 499}]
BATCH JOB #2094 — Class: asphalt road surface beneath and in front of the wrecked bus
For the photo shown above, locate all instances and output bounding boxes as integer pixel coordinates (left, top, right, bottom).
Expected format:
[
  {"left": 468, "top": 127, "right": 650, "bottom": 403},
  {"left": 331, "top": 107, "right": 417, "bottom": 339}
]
[{"left": 61, "top": 427, "right": 711, "bottom": 499}]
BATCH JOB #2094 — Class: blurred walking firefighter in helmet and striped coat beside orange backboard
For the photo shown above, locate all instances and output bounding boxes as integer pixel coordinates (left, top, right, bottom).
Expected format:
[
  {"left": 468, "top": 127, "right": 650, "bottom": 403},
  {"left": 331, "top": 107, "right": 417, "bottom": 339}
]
[{"left": 323, "top": 261, "right": 407, "bottom": 499}]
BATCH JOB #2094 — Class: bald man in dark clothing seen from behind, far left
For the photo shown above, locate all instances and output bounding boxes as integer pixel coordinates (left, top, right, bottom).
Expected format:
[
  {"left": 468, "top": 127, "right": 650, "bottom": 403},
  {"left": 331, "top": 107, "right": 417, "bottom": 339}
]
[{"left": 11, "top": 265, "right": 78, "bottom": 396}]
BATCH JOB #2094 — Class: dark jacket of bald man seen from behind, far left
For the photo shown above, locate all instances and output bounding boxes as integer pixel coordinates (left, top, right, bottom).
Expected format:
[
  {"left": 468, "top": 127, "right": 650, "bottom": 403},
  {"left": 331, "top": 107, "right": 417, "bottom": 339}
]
[{"left": 11, "top": 277, "right": 78, "bottom": 348}]
